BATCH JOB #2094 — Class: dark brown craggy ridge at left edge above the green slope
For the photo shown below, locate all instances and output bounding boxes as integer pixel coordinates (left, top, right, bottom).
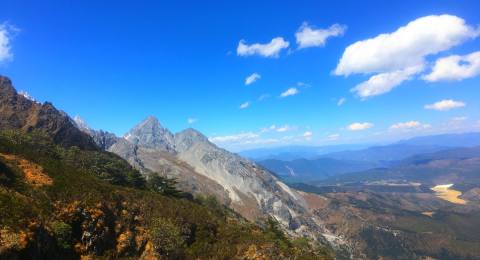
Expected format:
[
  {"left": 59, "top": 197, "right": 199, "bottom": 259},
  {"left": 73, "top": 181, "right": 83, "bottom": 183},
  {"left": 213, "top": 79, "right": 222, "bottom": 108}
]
[{"left": 0, "top": 76, "right": 98, "bottom": 150}]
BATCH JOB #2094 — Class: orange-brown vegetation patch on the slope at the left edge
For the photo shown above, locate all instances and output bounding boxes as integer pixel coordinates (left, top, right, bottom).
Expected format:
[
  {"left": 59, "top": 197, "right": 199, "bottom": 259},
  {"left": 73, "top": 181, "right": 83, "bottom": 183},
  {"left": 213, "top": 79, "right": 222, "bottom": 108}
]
[{"left": 0, "top": 153, "right": 53, "bottom": 187}]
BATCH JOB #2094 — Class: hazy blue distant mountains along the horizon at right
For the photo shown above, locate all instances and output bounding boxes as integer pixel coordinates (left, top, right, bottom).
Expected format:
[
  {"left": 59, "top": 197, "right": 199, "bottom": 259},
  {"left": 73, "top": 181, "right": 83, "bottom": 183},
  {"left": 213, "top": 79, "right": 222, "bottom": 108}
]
[{"left": 255, "top": 133, "right": 480, "bottom": 183}]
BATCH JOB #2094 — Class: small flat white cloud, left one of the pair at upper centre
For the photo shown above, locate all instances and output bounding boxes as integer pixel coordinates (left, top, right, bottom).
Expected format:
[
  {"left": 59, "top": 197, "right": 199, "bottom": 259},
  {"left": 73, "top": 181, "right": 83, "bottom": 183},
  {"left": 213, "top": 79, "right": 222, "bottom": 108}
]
[{"left": 237, "top": 37, "right": 290, "bottom": 58}]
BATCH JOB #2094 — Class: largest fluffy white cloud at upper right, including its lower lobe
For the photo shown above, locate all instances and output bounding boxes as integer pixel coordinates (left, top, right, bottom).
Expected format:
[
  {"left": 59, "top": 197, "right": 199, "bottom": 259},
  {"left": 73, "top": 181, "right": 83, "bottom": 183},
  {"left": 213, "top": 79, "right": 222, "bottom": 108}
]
[{"left": 334, "top": 15, "right": 480, "bottom": 98}]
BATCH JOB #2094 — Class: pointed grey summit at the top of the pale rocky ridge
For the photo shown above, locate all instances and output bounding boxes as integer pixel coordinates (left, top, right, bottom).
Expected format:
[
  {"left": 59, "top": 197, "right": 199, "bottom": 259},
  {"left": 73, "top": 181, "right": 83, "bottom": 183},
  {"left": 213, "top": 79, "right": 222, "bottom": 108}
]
[{"left": 124, "top": 116, "right": 175, "bottom": 152}]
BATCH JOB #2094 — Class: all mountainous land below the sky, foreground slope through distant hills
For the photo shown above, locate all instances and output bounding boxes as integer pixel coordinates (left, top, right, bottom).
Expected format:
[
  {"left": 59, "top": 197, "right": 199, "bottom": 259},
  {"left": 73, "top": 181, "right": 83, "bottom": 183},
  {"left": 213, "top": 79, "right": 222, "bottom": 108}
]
[{"left": 0, "top": 74, "right": 480, "bottom": 259}]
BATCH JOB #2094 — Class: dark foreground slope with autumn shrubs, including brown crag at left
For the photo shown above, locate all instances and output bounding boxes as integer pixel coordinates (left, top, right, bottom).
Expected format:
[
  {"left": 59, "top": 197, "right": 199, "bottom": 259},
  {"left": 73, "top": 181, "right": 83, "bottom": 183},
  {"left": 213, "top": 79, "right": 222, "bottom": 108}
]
[{"left": 0, "top": 78, "right": 329, "bottom": 259}]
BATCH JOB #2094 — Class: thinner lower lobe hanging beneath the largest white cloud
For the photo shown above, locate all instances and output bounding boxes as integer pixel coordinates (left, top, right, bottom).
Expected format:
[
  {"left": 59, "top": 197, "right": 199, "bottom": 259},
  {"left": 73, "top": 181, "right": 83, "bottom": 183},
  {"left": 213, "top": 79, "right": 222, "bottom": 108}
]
[{"left": 350, "top": 65, "right": 423, "bottom": 99}]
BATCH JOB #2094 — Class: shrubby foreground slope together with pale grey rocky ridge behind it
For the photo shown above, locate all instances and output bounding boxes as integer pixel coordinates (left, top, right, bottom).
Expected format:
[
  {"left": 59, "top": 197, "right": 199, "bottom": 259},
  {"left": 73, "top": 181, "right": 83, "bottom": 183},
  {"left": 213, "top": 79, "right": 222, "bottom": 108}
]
[{"left": 0, "top": 76, "right": 330, "bottom": 259}]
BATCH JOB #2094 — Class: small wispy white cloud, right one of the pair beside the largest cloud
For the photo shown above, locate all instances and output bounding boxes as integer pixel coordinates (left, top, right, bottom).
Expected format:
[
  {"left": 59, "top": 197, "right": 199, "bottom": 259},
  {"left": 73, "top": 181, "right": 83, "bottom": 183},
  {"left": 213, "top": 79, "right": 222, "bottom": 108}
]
[{"left": 295, "top": 22, "right": 347, "bottom": 49}]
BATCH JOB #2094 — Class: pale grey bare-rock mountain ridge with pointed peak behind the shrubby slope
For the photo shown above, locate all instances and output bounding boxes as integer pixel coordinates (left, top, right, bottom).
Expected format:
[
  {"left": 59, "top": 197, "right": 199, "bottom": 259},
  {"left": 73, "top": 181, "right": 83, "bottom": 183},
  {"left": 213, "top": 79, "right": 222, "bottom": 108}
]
[{"left": 75, "top": 117, "right": 330, "bottom": 238}]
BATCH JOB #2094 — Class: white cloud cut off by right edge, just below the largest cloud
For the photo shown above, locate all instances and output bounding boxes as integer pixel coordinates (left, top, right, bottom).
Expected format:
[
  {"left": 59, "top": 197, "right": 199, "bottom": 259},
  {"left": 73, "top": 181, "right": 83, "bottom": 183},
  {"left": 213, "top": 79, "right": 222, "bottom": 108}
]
[{"left": 423, "top": 51, "right": 480, "bottom": 82}]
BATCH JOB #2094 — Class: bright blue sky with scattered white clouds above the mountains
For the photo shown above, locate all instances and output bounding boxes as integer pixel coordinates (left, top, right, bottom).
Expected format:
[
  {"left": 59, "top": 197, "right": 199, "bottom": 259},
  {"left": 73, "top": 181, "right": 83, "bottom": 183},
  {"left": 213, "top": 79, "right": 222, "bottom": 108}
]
[{"left": 0, "top": 0, "right": 480, "bottom": 151}]
